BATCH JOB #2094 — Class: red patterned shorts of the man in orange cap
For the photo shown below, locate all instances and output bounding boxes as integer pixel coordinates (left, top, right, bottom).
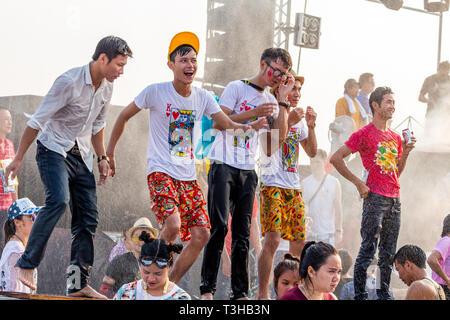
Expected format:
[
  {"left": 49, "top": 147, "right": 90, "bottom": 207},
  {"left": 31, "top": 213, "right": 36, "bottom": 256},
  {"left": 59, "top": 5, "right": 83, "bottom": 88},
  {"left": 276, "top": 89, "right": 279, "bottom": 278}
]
[{"left": 147, "top": 172, "right": 211, "bottom": 241}]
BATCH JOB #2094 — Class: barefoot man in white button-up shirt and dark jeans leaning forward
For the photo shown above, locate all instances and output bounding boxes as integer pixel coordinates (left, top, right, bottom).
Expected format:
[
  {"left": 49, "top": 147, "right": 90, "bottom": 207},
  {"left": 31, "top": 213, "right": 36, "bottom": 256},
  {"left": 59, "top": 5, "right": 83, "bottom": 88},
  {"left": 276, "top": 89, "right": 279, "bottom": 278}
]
[{"left": 6, "top": 36, "right": 132, "bottom": 299}]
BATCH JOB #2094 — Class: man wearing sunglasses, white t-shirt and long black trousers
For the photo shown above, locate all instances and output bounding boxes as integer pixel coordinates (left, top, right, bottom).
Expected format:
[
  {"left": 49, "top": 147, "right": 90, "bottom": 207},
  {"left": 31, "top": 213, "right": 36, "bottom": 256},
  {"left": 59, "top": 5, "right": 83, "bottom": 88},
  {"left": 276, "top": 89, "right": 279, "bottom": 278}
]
[{"left": 200, "top": 48, "right": 294, "bottom": 299}]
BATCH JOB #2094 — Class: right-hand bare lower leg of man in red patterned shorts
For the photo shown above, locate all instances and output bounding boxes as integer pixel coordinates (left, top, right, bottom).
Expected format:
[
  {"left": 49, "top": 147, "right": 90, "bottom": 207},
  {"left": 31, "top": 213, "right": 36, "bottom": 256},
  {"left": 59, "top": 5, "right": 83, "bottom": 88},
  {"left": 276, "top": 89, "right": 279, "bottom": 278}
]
[{"left": 169, "top": 227, "right": 209, "bottom": 283}]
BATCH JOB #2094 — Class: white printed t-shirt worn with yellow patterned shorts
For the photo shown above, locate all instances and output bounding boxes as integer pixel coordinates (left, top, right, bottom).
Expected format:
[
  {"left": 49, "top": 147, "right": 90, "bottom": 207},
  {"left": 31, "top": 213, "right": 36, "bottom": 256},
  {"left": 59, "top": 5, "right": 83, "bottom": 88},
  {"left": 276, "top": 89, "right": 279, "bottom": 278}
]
[{"left": 261, "top": 121, "right": 308, "bottom": 190}]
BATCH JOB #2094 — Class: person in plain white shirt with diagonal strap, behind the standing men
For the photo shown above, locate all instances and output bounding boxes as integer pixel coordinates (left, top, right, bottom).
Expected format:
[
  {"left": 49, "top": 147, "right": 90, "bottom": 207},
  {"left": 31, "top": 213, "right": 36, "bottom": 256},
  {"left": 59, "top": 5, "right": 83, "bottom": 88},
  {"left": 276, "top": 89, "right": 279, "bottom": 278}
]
[{"left": 302, "top": 149, "right": 343, "bottom": 246}]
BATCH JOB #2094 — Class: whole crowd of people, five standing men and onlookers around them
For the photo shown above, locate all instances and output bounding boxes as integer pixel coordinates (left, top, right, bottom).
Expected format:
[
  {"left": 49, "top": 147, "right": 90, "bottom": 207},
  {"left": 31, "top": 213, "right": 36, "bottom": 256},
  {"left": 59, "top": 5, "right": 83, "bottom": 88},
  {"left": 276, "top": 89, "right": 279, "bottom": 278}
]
[{"left": 0, "top": 32, "right": 450, "bottom": 300}]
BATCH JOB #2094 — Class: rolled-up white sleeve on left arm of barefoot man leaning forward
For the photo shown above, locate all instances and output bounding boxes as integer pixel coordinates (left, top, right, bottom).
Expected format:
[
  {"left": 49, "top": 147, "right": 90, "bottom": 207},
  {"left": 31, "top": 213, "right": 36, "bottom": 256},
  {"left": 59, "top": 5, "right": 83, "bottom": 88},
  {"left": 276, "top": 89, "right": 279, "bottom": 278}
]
[{"left": 27, "top": 75, "right": 73, "bottom": 130}]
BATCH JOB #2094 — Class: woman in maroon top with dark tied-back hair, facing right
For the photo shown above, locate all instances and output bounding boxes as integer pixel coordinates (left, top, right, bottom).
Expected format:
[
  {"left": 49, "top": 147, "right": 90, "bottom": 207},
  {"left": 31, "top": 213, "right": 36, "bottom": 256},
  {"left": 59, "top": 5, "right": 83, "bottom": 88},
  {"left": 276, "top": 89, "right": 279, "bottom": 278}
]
[{"left": 280, "top": 241, "right": 342, "bottom": 300}]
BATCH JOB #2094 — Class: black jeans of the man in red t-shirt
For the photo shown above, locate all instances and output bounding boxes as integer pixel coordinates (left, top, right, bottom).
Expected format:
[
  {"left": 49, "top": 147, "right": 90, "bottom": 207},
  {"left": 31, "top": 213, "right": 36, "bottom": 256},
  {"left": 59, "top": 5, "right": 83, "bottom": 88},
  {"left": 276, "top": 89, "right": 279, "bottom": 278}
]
[{"left": 354, "top": 193, "right": 400, "bottom": 300}]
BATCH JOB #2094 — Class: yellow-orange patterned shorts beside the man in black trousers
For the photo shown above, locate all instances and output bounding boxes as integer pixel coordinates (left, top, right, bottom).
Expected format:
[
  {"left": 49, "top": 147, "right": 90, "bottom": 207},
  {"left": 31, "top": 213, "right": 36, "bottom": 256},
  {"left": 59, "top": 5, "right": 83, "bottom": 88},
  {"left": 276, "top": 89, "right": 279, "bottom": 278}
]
[{"left": 260, "top": 186, "right": 306, "bottom": 241}]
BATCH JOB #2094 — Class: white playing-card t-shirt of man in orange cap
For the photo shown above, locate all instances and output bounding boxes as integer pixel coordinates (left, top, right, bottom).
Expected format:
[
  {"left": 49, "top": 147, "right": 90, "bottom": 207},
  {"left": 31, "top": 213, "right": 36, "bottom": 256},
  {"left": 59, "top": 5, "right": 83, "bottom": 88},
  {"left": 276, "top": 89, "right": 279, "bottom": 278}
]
[{"left": 134, "top": 82, "right": 221, "bottom": 181}]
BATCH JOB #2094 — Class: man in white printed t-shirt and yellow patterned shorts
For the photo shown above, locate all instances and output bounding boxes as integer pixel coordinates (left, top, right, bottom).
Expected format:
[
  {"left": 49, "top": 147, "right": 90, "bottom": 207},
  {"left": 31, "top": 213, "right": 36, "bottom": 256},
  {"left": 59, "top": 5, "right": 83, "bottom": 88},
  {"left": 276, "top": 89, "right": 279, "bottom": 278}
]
[{"left": 258, "top": 71, "right": 317, "bottom": 300}]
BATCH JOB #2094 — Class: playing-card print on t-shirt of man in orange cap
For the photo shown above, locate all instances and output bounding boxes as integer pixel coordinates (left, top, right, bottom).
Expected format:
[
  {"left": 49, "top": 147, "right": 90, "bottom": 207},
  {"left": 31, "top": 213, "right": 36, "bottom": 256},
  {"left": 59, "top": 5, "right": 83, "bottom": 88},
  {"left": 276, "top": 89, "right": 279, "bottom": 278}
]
[{"left": 168, "top": 106, "right": 195, "bottom": 159}]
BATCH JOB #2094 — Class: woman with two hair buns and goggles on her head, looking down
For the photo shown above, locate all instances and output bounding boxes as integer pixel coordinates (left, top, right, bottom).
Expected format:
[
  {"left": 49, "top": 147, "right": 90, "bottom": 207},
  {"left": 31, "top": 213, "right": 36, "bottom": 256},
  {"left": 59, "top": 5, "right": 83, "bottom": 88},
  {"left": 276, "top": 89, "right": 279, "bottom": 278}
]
[{"left": 113, "top": 231, "right": 191, "bottom": 300}]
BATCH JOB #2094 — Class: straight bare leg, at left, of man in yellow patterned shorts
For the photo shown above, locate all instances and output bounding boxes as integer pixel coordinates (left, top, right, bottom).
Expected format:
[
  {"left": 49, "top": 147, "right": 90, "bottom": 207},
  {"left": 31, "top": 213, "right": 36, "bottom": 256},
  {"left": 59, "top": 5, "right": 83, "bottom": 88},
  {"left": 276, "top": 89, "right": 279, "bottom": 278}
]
[{"left": 257, "top": 232, "right": 280, "bottom": 300}]
